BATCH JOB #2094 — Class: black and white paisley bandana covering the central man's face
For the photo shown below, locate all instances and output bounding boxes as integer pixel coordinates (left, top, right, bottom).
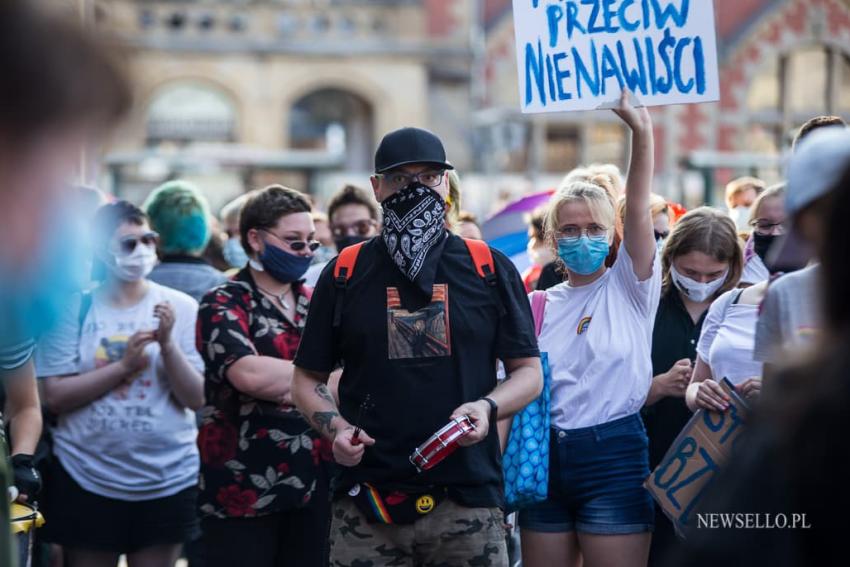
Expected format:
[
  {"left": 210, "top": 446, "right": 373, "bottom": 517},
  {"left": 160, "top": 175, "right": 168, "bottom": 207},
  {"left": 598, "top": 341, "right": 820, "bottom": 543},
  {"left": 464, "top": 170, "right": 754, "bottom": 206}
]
[{"left": 381, "top": 183, "right": 446, "bottom": 297}]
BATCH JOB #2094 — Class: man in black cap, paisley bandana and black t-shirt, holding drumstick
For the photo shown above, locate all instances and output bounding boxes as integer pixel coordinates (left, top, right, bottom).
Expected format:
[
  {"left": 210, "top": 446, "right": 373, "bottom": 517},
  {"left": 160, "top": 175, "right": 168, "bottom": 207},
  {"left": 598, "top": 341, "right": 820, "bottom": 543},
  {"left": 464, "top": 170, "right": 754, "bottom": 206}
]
[{"left": 292, "top": 128, "right": 542, "bottom": 566}]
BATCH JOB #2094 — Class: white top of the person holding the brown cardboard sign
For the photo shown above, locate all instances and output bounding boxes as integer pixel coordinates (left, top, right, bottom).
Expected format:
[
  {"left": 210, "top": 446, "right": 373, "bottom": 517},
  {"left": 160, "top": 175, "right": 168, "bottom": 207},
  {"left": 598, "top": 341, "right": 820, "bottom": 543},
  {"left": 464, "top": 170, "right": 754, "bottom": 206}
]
[{"left": 697, "top": 289, "right": 762, "bottom": 385}]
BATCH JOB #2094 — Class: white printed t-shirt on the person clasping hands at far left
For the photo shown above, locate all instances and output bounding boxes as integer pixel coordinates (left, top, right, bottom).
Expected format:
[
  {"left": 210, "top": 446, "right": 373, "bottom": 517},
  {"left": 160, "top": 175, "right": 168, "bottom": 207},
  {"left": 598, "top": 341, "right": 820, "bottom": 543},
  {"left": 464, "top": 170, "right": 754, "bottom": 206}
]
[{"left": 38, "top": 281, "right": 204, "bottom": 501}]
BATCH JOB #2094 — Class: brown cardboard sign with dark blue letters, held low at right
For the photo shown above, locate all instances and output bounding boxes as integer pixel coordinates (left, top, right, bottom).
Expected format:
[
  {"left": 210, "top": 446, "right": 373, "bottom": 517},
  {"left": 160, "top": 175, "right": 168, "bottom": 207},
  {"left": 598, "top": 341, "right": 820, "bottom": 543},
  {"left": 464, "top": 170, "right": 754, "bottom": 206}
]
[{"left": 644, "top": 378, "right": 748, "bottom": 534}]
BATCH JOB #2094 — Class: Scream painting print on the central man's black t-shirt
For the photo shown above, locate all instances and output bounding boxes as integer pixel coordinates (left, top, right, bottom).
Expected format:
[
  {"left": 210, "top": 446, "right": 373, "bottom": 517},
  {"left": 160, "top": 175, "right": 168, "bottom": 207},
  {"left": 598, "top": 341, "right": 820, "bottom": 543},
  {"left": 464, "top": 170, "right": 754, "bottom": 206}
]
[{"left": 387, "top": 284, "right": 452, "bottom": 360}]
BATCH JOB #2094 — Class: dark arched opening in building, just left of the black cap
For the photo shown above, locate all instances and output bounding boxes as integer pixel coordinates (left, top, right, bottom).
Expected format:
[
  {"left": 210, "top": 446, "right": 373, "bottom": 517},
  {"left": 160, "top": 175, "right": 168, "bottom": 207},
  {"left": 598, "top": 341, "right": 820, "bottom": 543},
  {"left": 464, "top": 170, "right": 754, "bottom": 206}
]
[{"left": 289, "top": 88, "right": 374, "bottom": 171}]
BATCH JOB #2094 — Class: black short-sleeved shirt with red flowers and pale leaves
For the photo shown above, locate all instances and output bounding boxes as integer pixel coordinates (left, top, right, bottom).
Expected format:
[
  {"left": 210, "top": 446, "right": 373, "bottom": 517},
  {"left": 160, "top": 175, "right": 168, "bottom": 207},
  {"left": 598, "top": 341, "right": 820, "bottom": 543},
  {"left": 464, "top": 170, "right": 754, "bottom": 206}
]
[{"left": 197, "top": 268, "right": 330, "bottom": 518}]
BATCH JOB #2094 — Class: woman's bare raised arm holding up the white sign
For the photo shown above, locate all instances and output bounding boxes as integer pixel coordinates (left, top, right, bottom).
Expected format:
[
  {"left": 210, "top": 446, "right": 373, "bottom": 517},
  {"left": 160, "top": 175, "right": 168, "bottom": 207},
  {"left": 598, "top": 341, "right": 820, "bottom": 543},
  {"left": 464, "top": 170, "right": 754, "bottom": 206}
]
[{"left": 614, "top": 90, "right": 656, "bottom": 281}]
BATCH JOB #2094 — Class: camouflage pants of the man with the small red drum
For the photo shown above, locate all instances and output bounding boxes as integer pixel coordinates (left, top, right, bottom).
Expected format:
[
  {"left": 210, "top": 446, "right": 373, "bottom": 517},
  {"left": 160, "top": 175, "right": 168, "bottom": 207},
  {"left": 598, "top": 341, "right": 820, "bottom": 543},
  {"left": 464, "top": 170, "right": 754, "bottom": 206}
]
[{"left": 330, "top": 498, "right": 508, "bottom": 567}]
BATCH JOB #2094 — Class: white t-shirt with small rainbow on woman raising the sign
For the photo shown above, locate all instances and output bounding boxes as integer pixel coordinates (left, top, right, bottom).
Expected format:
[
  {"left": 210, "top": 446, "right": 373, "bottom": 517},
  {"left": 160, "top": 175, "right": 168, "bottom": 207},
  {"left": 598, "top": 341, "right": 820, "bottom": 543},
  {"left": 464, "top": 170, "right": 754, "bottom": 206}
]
[{"left": 538, "top": 246, "right": 661, "bottom": 429}]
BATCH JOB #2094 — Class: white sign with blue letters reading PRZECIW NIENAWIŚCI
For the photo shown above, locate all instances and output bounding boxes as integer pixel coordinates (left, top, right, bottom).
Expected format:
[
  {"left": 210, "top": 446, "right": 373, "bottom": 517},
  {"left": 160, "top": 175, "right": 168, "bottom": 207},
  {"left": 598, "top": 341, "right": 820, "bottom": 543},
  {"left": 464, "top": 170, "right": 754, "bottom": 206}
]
[{"left": 513, "top": 0, "right": 720, "bottom": 113}]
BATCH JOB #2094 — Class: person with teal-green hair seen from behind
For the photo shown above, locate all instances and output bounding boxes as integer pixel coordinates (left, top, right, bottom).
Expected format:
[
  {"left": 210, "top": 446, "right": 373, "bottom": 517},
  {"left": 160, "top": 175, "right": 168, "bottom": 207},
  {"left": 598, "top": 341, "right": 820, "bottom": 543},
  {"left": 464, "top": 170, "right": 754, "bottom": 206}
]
[{"left": 143, "top": 181, "right": 227, "bottom": 301}]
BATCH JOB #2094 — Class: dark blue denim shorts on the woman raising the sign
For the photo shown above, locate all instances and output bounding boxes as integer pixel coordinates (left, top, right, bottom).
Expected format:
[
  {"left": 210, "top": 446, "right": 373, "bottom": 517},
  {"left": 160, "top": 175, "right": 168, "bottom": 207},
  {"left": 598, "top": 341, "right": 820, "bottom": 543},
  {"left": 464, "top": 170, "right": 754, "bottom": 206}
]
[{"left": 519, "top": 414, "right": 655, "bottom": 535}]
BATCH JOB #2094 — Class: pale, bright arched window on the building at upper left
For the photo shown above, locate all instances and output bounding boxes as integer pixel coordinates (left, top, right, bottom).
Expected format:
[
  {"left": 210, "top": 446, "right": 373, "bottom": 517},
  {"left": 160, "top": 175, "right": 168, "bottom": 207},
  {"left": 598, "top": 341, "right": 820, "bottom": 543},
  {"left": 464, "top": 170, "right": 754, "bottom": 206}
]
[{"left": 147, "top": 81, "right": 236, "bottom": 144}]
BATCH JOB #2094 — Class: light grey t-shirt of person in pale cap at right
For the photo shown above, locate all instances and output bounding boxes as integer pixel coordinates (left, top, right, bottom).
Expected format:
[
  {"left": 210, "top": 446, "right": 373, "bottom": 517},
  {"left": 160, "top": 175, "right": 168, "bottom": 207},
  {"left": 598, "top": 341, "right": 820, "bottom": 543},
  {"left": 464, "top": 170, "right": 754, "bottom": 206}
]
[{"left": 753, "top": 264, "right": 821, "bottom": 364}]
